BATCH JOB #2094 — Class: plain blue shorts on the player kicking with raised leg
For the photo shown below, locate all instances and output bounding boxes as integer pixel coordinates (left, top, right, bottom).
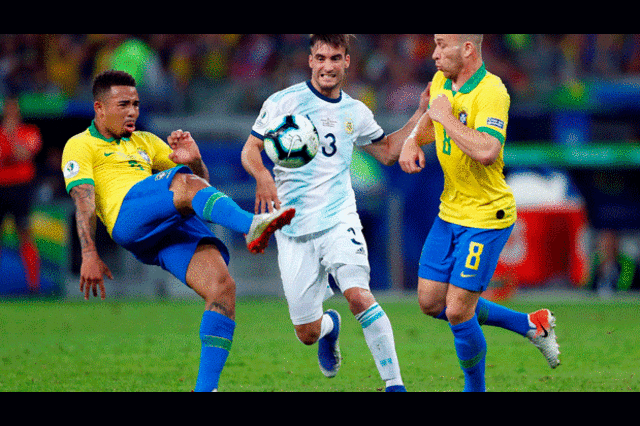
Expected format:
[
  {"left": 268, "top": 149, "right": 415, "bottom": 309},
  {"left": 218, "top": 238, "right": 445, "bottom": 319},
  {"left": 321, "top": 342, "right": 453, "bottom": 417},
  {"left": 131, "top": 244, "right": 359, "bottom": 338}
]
[{"left": 112, "top": 166, "right": 229, "bottom": 284}]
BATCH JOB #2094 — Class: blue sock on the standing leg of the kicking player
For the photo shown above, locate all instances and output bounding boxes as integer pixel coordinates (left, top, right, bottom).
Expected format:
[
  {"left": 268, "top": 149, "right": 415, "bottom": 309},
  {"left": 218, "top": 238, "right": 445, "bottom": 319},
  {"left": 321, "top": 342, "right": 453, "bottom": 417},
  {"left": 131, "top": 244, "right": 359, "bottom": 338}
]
[{"left": 195, "top": 311, "right": 236, "bottom": 392}]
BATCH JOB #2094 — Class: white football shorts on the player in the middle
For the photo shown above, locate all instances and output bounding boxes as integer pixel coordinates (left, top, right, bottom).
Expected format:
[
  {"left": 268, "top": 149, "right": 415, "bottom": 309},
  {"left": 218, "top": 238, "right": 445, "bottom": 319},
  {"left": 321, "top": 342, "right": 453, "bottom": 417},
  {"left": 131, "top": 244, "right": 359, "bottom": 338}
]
[{"left": 275, "top": 215, "right": 370, "bottom": 325}]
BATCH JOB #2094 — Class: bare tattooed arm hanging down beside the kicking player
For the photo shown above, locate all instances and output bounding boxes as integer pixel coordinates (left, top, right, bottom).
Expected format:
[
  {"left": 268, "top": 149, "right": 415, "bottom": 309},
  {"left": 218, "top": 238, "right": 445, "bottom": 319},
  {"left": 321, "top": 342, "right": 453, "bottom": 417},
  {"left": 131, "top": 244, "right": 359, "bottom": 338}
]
[{"left": 69, "top": 184, "right": 113, "bottom": 300}]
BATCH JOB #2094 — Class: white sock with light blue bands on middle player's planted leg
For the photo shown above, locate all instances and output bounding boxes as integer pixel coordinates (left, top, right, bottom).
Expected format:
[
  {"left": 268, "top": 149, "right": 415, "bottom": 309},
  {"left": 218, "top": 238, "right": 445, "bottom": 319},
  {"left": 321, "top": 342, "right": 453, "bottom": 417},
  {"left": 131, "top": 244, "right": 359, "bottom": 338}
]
[{"left": 356, "top": 303, "right": 402, "bottom": 385}]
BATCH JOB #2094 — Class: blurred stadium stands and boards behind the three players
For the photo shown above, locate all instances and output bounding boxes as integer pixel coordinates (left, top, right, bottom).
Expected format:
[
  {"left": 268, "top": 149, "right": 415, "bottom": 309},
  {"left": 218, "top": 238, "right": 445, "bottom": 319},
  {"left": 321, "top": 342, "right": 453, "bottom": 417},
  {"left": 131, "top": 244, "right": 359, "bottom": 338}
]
[{"left": 0, "top": 34, "right": 640, "bottom": 298}]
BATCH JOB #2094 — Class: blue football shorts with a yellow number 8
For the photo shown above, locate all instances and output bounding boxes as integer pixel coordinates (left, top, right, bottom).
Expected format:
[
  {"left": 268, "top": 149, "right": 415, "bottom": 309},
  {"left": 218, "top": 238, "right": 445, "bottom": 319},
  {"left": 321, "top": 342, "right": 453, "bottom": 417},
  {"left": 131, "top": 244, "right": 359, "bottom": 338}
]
[{"left": 418, "top": 217, "right": 513, "bottom": 291}]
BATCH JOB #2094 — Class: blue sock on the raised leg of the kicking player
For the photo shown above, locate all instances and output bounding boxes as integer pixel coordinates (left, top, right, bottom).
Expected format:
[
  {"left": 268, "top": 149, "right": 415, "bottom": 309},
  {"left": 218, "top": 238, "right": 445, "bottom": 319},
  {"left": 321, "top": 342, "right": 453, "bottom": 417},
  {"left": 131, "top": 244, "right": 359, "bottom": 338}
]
[{"left": 191, "top": 186, "right": 253, "bottom": 234}]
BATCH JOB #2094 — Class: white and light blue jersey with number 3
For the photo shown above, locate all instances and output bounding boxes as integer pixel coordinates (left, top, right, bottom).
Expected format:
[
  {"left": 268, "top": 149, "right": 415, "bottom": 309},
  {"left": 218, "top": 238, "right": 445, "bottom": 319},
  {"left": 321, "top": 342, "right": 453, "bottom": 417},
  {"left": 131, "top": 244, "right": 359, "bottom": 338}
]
[{"left": 251, "top": 81, "right": 385, "bottom": 237}]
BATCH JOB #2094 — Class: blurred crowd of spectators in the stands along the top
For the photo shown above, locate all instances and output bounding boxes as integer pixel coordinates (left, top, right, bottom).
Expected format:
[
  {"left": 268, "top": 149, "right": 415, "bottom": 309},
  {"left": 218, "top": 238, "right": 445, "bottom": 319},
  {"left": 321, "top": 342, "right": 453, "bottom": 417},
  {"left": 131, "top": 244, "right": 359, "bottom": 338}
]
[{"left": 0, "top": 34, "right": 640, "bottom": 114}]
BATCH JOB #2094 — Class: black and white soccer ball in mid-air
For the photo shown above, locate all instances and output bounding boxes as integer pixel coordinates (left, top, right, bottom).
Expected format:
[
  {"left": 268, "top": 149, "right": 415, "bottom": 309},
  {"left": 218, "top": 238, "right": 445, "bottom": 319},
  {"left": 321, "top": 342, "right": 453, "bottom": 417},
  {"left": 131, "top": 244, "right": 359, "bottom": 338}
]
[{"left": 264, "top": 114, "right": 320, "bottom": 168}]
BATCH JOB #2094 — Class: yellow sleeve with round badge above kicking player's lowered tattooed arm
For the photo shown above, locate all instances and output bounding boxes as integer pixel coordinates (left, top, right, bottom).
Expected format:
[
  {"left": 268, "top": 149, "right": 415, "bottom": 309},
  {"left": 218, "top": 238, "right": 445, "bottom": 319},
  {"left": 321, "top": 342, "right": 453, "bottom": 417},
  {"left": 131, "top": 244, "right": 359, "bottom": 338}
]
[{"left": 62, "top": 137, "right": 95, "bottom": 193}]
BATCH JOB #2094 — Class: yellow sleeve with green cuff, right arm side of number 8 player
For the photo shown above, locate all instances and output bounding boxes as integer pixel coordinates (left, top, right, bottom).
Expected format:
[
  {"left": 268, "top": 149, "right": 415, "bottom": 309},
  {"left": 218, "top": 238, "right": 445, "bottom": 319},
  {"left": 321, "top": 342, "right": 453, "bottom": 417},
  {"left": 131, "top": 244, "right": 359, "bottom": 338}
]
[{"left": 475, "top": 85, "right": 511, "bottom": 144}]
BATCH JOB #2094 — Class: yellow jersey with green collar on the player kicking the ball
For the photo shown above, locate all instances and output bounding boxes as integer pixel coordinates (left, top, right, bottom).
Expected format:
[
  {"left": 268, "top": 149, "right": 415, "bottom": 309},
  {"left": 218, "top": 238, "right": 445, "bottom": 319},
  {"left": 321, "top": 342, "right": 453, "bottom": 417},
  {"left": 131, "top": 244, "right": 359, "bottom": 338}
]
[{"left": 62, "top": 122, "right": 176, "bottom": 235}]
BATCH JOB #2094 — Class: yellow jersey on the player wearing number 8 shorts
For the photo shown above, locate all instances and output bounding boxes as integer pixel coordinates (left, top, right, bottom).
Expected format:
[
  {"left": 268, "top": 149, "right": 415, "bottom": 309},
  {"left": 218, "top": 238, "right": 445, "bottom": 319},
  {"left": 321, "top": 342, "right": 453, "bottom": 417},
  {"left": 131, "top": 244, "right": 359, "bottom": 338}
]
[{"left": 431, "top": 64, "right": 516, "bottom": 229}]
